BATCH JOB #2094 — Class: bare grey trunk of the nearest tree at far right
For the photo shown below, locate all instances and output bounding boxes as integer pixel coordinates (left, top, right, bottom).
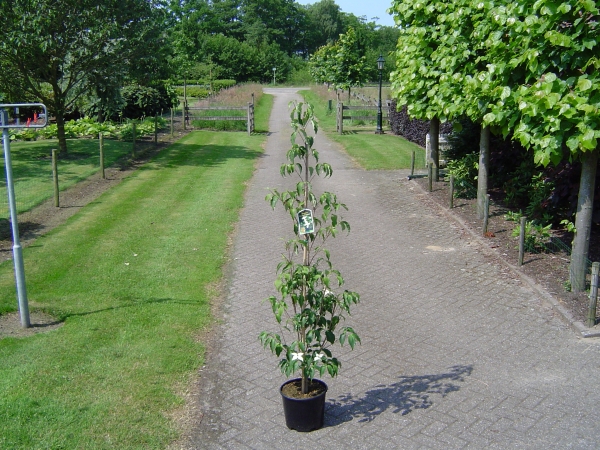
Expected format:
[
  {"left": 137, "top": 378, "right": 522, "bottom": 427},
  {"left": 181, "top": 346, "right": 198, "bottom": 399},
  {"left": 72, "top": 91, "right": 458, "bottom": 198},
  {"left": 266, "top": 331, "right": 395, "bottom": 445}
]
[{"left": 569, "top": 148, "right": 598, "bottom": 292}]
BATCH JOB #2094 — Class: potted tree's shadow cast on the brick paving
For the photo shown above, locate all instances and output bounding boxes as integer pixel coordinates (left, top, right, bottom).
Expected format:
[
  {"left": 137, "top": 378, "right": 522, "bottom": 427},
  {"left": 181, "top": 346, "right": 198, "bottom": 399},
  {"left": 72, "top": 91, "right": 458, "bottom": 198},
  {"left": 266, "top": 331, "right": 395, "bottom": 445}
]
[{"left": 325, "top": 365, "right": 473, "bottom": 426}]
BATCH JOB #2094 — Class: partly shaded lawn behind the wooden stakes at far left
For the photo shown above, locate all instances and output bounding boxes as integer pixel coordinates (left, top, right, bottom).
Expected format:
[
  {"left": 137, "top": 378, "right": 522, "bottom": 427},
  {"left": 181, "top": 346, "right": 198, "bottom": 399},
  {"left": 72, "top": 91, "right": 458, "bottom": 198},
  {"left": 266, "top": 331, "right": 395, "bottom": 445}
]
[{"left": 0, "top": 139, "right": 138, "bottom": 218}]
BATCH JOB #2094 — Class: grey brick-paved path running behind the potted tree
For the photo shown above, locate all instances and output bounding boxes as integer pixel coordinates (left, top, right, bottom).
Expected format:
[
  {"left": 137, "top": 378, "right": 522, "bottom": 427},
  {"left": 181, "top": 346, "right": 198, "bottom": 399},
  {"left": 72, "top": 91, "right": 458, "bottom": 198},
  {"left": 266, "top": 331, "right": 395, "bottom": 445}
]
[{"left": 186, "top": 89, "right": 600, "bottom": 450}]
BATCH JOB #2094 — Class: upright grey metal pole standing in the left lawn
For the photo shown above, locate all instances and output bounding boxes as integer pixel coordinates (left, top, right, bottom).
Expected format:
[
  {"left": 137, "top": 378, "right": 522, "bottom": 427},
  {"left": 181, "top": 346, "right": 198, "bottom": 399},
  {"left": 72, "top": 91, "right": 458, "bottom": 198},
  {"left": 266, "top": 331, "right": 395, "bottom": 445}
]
[{"left": 0, "top": 110, "right": 31, "bottom": 328}]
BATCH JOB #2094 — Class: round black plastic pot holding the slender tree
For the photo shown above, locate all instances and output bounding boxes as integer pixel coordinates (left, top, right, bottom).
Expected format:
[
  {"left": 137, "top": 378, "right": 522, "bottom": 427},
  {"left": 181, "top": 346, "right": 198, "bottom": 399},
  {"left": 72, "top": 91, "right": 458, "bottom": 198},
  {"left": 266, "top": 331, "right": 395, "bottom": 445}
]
[{"left": 279, "top": 378, "right": 327, "bottom": 432}]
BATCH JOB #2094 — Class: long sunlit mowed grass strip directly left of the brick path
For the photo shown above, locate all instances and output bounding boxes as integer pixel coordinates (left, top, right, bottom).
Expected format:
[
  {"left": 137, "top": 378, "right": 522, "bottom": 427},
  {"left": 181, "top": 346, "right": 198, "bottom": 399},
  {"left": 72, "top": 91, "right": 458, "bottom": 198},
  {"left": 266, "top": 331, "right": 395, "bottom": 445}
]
[{"left": 0, "top": 128, "right": 264, "bottom": 449}]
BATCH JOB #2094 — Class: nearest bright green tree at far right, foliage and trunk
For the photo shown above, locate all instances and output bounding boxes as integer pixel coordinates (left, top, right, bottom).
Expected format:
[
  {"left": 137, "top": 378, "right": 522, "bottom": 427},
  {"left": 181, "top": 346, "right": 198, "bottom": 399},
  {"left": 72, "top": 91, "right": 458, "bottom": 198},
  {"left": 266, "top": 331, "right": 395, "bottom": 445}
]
[{"left": 486, "top": 0, "right": 600, "bottom": 291}]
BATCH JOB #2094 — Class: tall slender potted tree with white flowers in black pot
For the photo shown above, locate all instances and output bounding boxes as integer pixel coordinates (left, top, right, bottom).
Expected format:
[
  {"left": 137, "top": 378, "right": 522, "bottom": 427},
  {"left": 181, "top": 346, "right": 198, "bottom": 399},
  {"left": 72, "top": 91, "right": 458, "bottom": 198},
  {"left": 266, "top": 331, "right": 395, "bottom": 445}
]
[{"left": 260, "top": 102, "right": 360, "bottom": 431}]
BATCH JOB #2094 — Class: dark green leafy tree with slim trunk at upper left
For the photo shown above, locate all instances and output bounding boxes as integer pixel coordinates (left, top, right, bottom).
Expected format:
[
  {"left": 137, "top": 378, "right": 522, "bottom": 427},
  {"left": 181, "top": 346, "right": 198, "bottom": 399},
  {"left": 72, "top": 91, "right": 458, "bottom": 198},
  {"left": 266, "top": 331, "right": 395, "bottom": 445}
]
[{"left": 0, "top": 0, "right": 163, "bottom": 154}]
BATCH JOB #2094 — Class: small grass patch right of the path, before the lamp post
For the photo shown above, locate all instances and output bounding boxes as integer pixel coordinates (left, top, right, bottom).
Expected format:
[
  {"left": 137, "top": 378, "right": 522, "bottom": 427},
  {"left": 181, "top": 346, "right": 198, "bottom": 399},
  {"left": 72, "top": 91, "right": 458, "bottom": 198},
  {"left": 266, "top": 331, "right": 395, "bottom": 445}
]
[{"left": 300, "top": 91, "right": 425, "bottom": 170}]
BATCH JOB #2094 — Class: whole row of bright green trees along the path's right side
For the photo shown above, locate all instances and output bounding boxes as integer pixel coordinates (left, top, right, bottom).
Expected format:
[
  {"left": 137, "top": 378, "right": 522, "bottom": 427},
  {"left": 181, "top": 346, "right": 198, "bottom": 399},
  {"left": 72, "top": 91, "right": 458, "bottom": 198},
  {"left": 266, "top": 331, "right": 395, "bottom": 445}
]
[{"left": 391, "top": 0, "right": 600, "bottom": 291}]
